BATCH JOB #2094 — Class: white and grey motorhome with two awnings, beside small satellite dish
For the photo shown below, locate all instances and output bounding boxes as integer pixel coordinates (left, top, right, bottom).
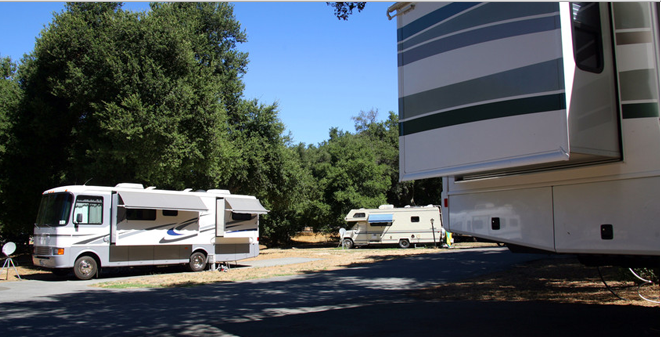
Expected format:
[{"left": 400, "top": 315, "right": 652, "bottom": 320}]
[{"left": 32, "top": 184, "right": 268, "bottom": 279}]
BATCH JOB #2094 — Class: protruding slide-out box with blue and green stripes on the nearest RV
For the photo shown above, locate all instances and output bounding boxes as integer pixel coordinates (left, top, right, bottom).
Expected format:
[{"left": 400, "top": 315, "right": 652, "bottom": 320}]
[{"left": 397, "top": 2, "right": 620, "bottom": 180}]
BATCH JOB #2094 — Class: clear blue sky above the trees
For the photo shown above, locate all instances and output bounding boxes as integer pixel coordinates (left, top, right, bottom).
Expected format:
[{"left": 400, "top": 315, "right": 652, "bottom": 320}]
[{"left": 0, "top": 2, "right": 397, "bottom": 145}]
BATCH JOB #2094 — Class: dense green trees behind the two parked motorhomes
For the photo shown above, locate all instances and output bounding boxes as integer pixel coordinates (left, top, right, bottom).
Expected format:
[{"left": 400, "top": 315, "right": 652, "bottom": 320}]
[{"left": 0, "top": 3, "right": 440, "bottom": 247}]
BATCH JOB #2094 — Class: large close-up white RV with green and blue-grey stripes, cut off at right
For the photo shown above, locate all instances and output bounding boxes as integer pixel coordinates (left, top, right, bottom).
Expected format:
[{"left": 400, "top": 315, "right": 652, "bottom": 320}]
[{"left": 388, "top": 2, "right": 659, "bottom": 263}]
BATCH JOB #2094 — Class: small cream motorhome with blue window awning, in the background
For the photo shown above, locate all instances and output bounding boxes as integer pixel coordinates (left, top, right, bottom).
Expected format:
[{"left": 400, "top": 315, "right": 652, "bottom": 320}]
[{"left": 342, "top": 205, "right": 445, "bottom": 248}]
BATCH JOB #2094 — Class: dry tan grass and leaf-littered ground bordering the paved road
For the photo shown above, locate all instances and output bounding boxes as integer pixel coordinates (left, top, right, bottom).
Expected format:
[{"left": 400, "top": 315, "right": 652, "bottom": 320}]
[{"left": 0, "top": 234, "right": 660, "bottom": 307}]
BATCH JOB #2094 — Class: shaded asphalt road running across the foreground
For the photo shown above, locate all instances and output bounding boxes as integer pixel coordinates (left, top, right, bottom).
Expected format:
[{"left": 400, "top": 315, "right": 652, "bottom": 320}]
[{"left": 0, "top": 248, "right": 659, "bottom": 337}]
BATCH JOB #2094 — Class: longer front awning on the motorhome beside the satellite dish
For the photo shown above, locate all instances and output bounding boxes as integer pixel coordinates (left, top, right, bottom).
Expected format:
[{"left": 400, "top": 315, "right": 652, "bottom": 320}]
[{"left": 119, "top": 192, "right": 207, "bottom": 211}]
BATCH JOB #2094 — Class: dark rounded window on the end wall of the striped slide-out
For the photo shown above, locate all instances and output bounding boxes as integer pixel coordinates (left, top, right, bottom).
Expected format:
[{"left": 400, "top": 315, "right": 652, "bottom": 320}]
[{"left": 571, "top": 2, "right": 604, "bottom": 73}]
